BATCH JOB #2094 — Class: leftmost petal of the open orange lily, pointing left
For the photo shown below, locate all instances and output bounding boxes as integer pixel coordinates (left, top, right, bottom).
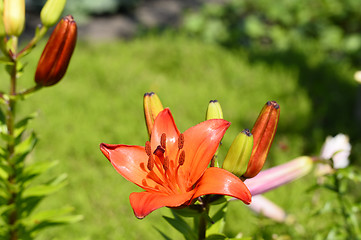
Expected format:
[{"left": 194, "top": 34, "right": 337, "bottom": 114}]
[{"left": 100, "top": 143, "right": 149, "bottom": 190}]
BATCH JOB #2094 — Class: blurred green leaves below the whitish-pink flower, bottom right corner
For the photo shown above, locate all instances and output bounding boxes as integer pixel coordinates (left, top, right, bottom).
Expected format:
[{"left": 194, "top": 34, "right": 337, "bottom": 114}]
[{"left": 310, "top": 167, "right": 361, "bottom": 239}]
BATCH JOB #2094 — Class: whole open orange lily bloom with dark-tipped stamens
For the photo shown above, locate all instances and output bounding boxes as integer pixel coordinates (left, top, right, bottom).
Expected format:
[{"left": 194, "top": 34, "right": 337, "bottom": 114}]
[{"left": 100, "top": 108, "right": 251, "bottom": 219}]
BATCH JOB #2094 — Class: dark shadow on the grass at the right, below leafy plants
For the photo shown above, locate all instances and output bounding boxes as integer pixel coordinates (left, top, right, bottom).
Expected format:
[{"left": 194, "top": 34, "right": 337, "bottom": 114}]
[{"left": 245, "top": 47, "right": 361, "bottom": 158}]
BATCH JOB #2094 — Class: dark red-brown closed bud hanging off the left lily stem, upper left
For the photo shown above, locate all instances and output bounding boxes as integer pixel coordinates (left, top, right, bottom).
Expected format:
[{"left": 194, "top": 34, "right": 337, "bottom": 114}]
[{"left": 35, "top": 15, "right": 77, "bottom": 86}]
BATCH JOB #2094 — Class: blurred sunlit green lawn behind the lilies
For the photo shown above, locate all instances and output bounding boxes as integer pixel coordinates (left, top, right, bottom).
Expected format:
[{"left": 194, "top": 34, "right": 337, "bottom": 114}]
[{"left": 1, "top": 34, "right": 356, "bottom": 239}]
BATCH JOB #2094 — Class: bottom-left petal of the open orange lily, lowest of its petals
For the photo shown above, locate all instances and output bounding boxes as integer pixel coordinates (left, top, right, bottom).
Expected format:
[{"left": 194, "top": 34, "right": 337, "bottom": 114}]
[{"left": 129, "top": 190, "right": 194, "bottom": 219}]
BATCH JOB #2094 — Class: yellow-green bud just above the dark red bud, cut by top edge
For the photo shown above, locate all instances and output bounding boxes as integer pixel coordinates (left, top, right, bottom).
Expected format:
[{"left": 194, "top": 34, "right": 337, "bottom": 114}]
[{"left": 40, "top": 0, "right": 66, "bottom": 27}]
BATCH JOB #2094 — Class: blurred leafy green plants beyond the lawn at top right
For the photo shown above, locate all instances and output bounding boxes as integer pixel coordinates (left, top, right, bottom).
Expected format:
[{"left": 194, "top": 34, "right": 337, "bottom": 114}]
[{"left": 184, "top": 0, "right": 361, "bottom": 64}]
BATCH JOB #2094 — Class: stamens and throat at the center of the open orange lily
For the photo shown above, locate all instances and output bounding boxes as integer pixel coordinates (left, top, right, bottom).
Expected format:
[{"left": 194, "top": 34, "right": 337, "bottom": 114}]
[{"left": 145, "top": 133, "right": 187, "bottom": 194}]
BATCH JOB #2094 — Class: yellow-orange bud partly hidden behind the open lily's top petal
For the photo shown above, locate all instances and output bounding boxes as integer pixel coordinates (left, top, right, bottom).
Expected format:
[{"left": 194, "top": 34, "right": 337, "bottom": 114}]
[{"left": 143, "top": 92, "right": 164, "bottom": 136}]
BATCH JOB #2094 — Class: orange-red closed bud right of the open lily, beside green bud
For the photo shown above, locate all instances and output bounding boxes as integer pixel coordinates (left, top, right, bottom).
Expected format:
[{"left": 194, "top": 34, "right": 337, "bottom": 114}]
[{"left": 243, "top": 101, "right": 280, "bottom": 178}]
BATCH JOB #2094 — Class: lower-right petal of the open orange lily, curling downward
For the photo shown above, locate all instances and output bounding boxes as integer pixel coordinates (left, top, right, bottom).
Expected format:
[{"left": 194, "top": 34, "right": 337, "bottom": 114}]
[{"left": 193, "top": 167, "right": 252, "bottom": 204}]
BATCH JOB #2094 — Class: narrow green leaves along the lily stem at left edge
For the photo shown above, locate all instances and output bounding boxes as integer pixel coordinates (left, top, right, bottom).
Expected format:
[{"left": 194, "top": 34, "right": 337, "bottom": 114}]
[{"left": 0, "top": 106, "right": 81, "bottom": 240}]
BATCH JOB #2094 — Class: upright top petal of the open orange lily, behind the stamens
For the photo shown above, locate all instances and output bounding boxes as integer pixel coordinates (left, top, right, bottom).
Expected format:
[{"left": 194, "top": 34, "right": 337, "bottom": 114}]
[{"left": 150, "top": 108, "right": 179, "bottom": 157}]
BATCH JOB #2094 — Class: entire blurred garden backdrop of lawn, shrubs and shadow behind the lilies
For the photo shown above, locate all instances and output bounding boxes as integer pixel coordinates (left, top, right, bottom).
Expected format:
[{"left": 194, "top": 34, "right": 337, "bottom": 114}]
[{"left": 7, "top": 0, "right": 361, "bottom": 240}]
